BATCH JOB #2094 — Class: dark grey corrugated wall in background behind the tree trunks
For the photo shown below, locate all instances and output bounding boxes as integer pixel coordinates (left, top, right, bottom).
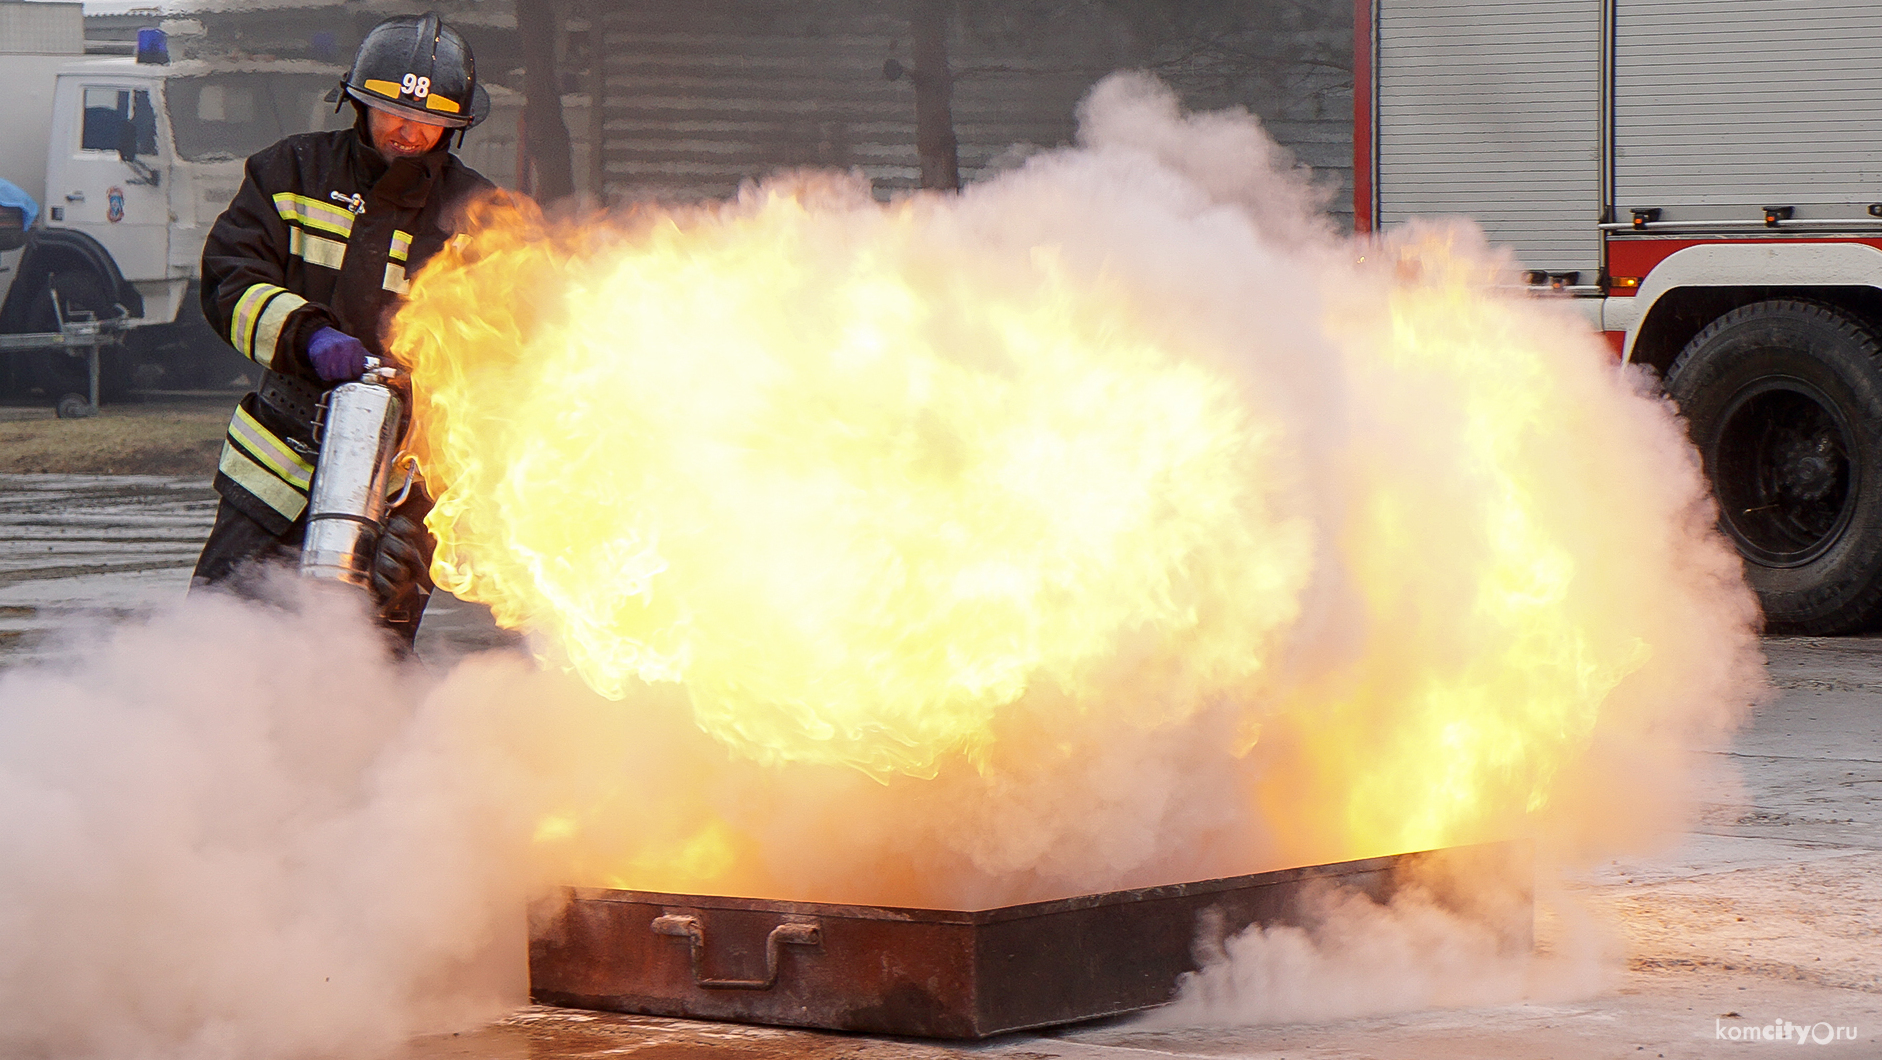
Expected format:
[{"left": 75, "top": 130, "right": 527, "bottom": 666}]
[{"left": 154, "top": 0, "right": 1353, "bottom": 222}]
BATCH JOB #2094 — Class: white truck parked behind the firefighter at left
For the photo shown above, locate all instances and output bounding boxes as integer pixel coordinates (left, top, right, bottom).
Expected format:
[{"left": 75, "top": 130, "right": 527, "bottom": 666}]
[{"left": 0, "top": 0, "right": 352, "bottom": 410}]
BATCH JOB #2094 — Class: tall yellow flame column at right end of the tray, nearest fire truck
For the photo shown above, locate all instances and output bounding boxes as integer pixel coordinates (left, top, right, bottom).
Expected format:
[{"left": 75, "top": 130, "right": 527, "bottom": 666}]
[{"left": 1261, "top": 237, "right": 1675, "bottom": 859}]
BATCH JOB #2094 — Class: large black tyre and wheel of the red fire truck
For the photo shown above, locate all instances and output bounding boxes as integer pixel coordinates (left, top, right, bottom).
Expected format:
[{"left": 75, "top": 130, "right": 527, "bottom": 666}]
[{"left": 1667, "top": 299, "right": 1882, "bottom": 634}]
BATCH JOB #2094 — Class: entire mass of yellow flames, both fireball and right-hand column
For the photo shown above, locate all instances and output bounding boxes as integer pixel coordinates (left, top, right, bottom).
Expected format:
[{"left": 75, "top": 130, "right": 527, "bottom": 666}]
[{"left": 391, "top": 181, "right": 1743, "bottom": 900}]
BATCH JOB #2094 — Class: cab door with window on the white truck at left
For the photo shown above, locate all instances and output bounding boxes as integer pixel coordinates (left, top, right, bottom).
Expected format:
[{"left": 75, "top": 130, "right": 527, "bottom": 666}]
[{"left": 45, "top": 77, "right": 169, "bottom": 289}]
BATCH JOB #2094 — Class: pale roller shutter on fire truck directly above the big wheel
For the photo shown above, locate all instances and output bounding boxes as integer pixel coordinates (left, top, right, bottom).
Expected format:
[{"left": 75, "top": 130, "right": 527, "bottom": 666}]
[{"left": 1615, "top": 0, "right": 1882, "bottom": 220}]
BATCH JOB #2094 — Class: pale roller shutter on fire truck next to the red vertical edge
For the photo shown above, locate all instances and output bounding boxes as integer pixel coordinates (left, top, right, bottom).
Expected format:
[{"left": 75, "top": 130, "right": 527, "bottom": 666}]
[{"left": 1376, "top": 0, "right": 1602, "bottom": 282}]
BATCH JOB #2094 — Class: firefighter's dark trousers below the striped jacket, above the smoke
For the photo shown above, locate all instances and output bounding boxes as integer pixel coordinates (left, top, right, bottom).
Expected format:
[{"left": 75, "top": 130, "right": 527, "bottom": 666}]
[{"left": 190, "top": 490, "right": 433, "bottom": 653}]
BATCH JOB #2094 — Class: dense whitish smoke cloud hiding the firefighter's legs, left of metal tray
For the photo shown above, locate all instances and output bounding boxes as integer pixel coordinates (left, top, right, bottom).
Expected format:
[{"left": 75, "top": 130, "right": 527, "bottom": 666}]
[{"left": 0, "top": 593, "right": 529, "bottom": 1058}]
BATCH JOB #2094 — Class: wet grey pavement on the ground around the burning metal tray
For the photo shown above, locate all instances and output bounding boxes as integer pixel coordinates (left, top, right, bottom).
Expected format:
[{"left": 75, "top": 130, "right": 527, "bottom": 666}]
[{"left": 0, "top": 474, "right": 1882, "bottom": 1060}]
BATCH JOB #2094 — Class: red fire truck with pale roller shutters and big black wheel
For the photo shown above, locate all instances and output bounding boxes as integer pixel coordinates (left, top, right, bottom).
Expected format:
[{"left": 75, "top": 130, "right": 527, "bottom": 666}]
[{"left": 1353, "top": 0, "right": 1882, "bottom": 634}]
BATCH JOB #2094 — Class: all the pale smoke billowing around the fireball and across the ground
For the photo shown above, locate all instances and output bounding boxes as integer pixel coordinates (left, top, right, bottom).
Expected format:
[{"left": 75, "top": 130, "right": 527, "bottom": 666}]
[{"left": 0, "top": 77, "right": 1758, "bottom": 1058}]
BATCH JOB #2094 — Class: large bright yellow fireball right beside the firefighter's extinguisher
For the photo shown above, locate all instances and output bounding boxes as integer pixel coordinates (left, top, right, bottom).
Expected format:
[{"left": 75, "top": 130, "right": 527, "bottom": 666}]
[{"left": 397, "top": 192, "right": 1310, "bottom": 776}]
